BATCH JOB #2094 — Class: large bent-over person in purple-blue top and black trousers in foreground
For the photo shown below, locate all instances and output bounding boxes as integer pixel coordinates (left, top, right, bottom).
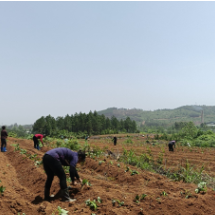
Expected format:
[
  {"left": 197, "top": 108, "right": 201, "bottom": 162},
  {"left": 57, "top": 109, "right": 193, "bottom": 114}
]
[{"left": 43, "top": 148, "right": 86, "bottom": 202}]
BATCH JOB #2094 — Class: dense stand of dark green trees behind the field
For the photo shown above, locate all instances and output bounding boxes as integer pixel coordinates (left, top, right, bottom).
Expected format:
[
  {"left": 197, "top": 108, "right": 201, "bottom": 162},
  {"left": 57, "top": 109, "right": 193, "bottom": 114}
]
[{"left": 32, "top": 111, "right": 137, "bottom": 135}]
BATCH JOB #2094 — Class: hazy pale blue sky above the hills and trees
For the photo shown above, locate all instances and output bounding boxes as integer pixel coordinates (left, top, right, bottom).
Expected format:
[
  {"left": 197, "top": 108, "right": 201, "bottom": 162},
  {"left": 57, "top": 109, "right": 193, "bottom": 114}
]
[{"left": 0, "top": 1, "right": 215, "bottom": 125}]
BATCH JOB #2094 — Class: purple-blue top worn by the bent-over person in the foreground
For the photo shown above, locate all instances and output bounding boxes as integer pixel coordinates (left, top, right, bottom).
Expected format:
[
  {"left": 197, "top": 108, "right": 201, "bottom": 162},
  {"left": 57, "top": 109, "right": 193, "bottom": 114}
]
[{"left": 46, "top": 148, "right": 78, "bottom": 167}]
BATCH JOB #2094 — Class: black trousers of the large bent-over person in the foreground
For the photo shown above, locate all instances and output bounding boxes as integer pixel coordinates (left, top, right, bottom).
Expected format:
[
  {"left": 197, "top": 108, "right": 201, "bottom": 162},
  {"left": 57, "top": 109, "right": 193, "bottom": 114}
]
[{"left": 43, "top": 154, "right": 67, "bottom": 189}]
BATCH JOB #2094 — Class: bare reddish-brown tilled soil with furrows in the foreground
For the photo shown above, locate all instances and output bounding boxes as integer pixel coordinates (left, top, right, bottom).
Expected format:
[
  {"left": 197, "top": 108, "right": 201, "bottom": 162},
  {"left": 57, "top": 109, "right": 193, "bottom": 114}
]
[{"left": 0, "top": 138, "right": 215, "bottom": 215}]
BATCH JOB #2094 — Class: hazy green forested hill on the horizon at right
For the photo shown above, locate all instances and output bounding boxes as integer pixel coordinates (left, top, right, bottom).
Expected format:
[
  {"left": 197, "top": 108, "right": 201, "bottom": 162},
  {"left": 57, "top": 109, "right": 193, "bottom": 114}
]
[{"left": 98, "top": 105, "right": 215, "bottom": 126}]
